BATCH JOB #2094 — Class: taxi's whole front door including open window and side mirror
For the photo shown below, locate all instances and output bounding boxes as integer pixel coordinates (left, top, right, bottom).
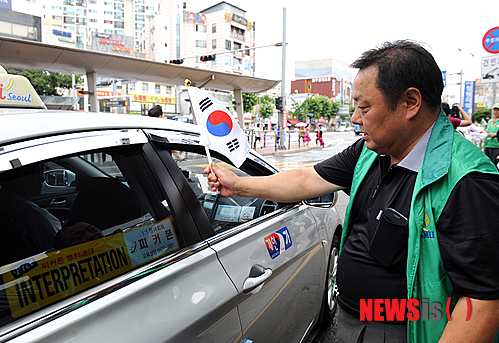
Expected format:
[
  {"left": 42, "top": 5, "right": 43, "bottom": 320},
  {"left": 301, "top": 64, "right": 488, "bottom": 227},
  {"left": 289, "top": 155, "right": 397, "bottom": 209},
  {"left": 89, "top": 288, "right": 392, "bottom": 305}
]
[{"left": 152, "top": 140, "right": 326, "bottom": 342}]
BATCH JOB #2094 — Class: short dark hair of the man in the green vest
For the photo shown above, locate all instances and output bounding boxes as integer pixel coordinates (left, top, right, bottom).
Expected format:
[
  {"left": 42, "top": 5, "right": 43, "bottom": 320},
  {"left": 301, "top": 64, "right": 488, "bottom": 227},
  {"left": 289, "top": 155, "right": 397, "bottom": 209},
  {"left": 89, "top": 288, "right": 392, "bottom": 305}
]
[{"left": 352, "top": 40, "right": 444, "bottom": 110}]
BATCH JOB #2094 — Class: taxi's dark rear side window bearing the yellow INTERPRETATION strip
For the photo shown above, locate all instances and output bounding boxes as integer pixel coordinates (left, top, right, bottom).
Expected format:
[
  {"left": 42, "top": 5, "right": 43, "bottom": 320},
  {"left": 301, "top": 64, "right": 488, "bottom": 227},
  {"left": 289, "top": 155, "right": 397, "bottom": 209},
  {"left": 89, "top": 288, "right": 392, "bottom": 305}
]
[{"left": 0, "top": 145, "right": 184, "bottom": 326}]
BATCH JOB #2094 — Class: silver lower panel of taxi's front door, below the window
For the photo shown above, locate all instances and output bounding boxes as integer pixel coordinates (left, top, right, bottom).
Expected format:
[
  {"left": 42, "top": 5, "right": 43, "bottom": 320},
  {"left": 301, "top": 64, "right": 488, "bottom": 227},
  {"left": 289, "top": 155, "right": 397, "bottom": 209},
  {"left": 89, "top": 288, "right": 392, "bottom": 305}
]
[{"left": 208, "top": 205, "right": 324, "bottom": 342}]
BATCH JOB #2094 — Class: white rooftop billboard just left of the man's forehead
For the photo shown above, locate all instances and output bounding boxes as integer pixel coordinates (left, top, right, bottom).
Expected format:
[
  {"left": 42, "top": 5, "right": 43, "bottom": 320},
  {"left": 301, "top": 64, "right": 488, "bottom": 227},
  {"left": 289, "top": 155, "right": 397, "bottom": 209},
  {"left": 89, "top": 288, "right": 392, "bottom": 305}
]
[{"left": 295, "top": 58, "right": 353, "bottom": 82}]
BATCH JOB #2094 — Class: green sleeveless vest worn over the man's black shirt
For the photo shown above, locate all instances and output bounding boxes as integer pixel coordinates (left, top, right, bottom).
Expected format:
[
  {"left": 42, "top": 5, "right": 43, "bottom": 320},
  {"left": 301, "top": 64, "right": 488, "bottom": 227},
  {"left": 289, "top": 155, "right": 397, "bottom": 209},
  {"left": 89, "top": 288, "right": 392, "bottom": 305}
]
[{"left": 340, "top": 111, "right": 499, "bottom": 343}]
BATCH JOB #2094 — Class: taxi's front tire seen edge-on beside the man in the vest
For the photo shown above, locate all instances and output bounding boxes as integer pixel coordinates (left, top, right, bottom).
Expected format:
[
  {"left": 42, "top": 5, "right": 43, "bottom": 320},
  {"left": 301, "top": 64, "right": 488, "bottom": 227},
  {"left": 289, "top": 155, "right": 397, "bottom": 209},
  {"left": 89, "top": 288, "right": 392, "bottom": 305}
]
[{"left": 322, "top": 235, "right": 340, "bottom": 326}]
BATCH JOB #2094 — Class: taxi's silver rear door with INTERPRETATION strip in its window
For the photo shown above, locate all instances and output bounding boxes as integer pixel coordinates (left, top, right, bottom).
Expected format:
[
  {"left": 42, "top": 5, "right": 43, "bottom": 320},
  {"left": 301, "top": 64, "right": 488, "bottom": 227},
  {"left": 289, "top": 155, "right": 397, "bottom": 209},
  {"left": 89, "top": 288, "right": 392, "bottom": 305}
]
[{"left": 0, "top": 130, "right": 242, "bottom": 343}]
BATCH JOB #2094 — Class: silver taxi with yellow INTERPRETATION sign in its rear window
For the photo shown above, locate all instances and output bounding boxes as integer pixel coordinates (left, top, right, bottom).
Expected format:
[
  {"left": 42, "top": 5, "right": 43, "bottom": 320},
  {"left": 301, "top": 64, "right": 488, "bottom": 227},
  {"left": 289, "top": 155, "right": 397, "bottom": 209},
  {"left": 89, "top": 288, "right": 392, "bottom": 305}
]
[{"left": 0, "top": 68, "right": 342, "bottom": 343}]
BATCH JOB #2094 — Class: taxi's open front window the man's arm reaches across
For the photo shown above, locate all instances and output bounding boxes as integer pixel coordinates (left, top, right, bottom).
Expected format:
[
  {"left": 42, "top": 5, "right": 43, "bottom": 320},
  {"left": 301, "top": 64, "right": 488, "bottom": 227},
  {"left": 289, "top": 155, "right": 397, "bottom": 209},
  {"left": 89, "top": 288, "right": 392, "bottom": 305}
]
[{"left": 170, "top": 151, "right": 281, "bottom": 233}]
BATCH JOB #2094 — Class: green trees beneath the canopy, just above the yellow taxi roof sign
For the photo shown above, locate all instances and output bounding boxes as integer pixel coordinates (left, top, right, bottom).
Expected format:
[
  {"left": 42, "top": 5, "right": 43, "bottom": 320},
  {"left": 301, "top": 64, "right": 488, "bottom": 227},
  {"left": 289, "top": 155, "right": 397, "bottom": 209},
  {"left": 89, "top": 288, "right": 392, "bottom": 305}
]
[{"left": 6, "top": 68, "right": 81, "bottom": 95}]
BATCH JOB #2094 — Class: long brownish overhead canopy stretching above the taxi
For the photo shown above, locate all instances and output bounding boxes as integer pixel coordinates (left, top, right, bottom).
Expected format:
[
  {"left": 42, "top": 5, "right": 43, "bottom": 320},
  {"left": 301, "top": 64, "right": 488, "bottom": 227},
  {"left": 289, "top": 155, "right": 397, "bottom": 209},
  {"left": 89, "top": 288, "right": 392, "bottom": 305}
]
[{"left": 0, "top": 37, "right": 280, "bottom": 93}]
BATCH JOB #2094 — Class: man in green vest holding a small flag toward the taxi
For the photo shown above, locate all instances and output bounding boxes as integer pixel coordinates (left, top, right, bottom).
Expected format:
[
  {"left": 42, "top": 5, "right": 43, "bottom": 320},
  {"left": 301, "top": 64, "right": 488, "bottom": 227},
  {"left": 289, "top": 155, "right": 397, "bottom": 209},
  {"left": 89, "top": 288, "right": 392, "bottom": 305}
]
[{"left": 205, "top": 41, "right": 499, "bottom": 343}]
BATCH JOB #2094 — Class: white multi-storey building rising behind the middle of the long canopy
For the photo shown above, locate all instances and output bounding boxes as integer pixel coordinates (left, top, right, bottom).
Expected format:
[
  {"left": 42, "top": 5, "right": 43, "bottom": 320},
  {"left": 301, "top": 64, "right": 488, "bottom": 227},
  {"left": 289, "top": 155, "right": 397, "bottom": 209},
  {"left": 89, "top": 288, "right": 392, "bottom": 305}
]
[{"left": 143, "top": 0, "right": 255, "bottom": 76}]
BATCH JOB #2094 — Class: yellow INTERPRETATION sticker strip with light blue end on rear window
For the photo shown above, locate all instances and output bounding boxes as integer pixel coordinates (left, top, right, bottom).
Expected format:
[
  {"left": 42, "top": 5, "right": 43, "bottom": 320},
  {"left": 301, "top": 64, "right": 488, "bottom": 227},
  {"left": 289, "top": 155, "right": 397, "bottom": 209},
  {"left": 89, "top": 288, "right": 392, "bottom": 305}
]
[{"left": 0, "top": 217, "right": 179, "bottom": 318}]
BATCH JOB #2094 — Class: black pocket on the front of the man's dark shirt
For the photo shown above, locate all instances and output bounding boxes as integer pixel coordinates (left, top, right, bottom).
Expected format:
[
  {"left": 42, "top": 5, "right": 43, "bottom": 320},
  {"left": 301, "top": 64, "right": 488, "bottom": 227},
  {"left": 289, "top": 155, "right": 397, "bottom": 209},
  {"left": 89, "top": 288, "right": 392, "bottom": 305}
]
[{"left": 369, "top": 208, "right": 409, "bottom": 267}]
